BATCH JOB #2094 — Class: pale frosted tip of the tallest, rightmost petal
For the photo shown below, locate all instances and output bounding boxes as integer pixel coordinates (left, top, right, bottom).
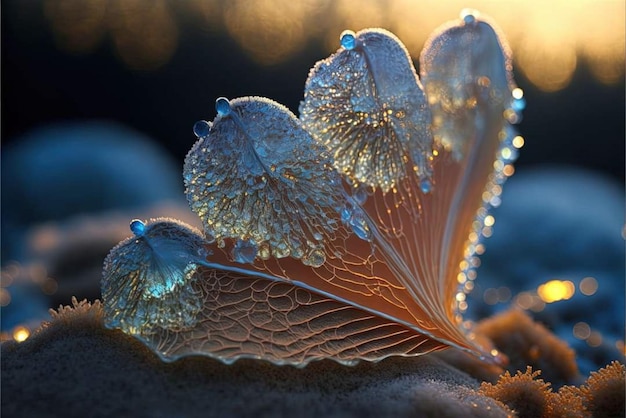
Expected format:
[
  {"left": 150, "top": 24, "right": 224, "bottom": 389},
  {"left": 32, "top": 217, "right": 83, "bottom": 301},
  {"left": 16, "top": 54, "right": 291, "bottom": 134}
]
[{"left": 420, "top": 10, "right": 521, "bottom": 160}]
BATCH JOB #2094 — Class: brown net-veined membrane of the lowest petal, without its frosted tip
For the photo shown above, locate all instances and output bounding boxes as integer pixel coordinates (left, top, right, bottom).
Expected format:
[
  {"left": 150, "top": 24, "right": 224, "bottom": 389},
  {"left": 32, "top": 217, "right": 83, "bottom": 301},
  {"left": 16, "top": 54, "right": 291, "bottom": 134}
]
[{"left": 140, "top": 268, "right": 442, "bottom": 366}]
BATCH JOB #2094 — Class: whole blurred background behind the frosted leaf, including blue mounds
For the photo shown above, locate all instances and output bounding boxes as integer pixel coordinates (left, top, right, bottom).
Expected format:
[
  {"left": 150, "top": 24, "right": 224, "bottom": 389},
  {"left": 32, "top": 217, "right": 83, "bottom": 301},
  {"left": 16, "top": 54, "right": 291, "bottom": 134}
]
[{"left": 0, "top": 0, "right": 625, "bottom": 367}]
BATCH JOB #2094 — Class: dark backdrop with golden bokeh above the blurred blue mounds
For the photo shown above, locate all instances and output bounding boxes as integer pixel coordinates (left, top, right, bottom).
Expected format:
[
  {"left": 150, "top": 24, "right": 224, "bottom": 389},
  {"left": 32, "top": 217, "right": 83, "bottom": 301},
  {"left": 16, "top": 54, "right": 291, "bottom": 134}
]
[{"left": 2, "top": 0, "right": 625, "bottom": 182}]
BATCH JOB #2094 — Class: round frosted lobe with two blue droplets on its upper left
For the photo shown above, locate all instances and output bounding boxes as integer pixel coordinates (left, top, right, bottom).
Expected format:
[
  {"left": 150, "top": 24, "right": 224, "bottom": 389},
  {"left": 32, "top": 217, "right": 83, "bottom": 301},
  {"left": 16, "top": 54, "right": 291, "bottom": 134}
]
[{"left": 184, "top": 97, "right": 343, "bottom": 264}]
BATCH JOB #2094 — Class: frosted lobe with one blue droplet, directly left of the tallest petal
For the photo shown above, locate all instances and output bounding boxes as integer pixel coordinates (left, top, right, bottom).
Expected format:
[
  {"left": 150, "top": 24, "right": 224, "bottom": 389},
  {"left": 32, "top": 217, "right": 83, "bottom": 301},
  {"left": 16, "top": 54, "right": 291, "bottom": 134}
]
[{"left": 300, "top": 29, "right": 432, "bottom": 192}]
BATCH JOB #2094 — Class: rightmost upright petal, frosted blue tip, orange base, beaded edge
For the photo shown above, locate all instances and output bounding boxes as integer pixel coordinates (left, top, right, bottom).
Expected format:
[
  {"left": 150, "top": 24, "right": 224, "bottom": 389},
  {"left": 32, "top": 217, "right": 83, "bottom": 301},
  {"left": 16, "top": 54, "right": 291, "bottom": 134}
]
[{"left": 420, "top": 11, "right": 521, "bottom": 316}]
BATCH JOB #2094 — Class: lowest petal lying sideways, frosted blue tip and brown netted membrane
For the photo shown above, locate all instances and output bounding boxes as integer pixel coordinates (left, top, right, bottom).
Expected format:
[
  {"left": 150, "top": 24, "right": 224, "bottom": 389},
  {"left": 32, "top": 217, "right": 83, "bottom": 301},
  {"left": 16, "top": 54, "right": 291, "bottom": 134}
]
[{"left": 103, "top": 219, "right": 443, "bottom": 365}]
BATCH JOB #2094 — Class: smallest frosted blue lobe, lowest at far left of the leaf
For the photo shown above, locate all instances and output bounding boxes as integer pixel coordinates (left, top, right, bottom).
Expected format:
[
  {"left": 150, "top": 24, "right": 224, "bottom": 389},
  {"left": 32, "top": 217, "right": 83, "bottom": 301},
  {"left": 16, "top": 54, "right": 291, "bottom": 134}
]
[{"left": 102, "top": 218, "right": 206, "bottom": 333}]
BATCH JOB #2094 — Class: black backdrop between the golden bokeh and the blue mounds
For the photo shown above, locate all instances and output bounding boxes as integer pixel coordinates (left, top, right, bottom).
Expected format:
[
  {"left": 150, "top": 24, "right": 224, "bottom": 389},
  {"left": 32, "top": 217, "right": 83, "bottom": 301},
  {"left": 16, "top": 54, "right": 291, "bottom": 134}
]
[{"left": 1, "top": 0, "right": 625, "bottom": 185}]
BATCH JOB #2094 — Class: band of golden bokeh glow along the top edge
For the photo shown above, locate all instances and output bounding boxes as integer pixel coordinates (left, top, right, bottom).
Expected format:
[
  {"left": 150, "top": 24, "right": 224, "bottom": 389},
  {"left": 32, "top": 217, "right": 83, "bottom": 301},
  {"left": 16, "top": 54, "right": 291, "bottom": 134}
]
[{"left": 44, "top": 0, "right": 625, "bottom": 91}]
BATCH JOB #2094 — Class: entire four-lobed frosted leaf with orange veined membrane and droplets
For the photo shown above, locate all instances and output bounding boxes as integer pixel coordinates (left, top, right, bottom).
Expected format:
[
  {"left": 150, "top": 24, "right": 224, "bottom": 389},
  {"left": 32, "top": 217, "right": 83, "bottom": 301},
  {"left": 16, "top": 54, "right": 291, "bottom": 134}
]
[{"left": 103, "top": 13, "right": 523, "bottom": 366}]
